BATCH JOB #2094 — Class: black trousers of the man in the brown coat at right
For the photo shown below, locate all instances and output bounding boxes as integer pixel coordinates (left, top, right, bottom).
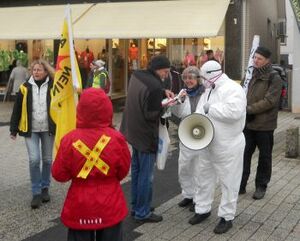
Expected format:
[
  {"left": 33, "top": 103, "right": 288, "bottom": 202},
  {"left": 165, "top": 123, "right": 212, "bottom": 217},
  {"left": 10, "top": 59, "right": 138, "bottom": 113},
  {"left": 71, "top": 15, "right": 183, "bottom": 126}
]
[{"left": 241, "top": 129, "right": 274, "bottom": 189}]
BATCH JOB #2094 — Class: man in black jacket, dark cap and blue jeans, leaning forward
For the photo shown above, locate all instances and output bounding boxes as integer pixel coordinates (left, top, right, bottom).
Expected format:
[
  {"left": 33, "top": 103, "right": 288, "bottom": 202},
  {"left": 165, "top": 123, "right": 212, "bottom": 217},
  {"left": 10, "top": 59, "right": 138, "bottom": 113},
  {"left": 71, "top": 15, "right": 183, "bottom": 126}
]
[{"left": 120, "top": 55, "right": 174, "bottom": 222}]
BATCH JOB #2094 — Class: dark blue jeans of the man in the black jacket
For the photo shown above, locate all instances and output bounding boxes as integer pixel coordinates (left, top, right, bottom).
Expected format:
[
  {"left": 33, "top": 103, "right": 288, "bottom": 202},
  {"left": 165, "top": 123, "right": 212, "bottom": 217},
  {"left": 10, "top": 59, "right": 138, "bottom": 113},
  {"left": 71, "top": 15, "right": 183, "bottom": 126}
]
[{"left": 131, "top": 147, "right": 156, "bottom": 219}]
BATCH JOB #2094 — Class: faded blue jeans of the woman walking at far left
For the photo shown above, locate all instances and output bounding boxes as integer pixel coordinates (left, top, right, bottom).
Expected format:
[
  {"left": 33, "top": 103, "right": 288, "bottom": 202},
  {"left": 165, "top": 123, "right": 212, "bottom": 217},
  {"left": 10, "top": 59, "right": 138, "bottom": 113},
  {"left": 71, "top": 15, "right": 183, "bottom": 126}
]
[{"left": 25, "top": 132, "right": 54, "bottom": 195}]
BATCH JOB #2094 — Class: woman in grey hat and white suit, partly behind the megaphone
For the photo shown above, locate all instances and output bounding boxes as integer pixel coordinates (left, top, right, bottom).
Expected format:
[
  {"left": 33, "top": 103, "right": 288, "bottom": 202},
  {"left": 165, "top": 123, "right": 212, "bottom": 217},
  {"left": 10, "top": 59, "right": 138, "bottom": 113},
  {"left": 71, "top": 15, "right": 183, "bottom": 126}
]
[{"left": 171, "top": 66, "right": 205, "bottom": 211}]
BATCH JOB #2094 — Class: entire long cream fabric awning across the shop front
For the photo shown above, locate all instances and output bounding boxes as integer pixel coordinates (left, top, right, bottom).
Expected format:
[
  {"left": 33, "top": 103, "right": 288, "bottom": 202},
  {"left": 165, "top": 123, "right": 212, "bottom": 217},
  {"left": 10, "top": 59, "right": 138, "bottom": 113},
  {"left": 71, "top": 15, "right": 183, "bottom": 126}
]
[{"left": 0, "top": 0, "right": 229, "bottom": 39}]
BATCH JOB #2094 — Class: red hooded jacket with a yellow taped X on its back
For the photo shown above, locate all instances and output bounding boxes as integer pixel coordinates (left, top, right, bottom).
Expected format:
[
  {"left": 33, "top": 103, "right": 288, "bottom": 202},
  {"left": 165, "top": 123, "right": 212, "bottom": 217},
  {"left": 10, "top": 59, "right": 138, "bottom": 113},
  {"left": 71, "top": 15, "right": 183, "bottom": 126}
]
[{"left": 52, "top": 88, "right": 130, "bottom": 230}]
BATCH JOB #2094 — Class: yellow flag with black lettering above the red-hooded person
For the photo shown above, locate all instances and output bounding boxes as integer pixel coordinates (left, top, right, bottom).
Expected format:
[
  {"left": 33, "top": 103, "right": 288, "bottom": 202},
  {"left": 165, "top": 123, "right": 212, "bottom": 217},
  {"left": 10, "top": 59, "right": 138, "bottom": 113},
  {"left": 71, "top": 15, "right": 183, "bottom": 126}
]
[{"left": 50, "top": 6, "right": 81, "bottom": 156}]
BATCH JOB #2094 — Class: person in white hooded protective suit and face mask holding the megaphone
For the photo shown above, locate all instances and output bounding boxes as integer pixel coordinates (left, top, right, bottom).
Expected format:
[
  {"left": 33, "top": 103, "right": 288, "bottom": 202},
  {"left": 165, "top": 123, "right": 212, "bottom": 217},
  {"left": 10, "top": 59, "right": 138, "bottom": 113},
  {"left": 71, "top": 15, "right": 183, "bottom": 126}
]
[{"left": 189, "top": 60, "right": 246, "bottom": 234}]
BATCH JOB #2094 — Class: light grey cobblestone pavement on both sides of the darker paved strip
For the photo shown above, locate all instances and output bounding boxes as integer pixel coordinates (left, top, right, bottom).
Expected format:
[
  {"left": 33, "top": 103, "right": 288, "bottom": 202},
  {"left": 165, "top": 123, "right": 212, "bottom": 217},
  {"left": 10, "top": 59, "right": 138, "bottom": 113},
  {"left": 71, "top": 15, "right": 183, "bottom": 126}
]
[{"left": 0, "top": 100, "right": 300, "bottom": 241}]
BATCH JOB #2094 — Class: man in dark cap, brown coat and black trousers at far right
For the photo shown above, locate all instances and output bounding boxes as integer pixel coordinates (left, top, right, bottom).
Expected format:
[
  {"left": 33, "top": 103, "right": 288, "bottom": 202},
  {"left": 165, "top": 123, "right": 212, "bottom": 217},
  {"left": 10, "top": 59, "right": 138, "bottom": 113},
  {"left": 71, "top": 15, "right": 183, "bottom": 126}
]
[{"left": 239, "top": 47, "right": 282, "bottom": 199}]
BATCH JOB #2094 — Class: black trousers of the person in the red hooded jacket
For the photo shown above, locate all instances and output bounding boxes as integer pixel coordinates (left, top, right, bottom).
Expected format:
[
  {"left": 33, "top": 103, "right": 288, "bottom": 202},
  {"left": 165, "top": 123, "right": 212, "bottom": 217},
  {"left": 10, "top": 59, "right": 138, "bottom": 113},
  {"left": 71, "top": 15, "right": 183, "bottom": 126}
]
[{"left": 68, "top": 222, "right": 123, "bottom": 241}]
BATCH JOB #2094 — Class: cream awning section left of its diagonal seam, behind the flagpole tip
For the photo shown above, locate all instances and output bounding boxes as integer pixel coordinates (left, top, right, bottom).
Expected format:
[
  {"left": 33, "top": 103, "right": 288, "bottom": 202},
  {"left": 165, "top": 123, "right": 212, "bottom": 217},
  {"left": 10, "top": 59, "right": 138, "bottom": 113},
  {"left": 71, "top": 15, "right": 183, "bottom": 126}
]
[{"left": 0, "top": 4, "right": 92, "bottom": 40}]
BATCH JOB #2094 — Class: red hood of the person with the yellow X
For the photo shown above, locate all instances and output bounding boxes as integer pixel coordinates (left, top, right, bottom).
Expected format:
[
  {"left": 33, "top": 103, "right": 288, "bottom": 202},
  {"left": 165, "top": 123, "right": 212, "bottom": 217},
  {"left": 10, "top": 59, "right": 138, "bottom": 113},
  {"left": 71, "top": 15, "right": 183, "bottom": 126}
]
[{"left": 76, "top": 88, "right": 113, "bottom": 128}]
